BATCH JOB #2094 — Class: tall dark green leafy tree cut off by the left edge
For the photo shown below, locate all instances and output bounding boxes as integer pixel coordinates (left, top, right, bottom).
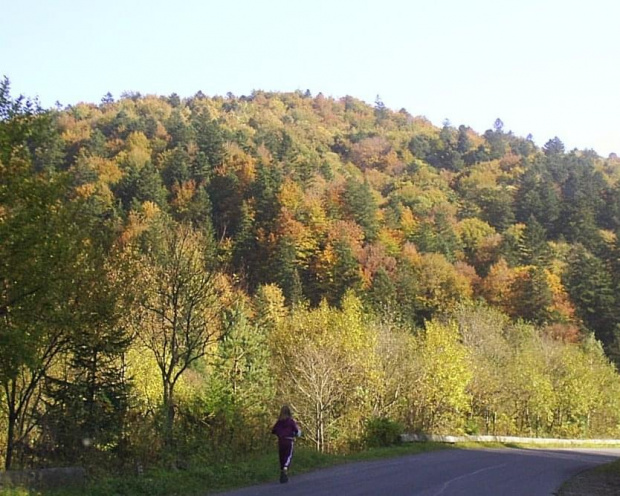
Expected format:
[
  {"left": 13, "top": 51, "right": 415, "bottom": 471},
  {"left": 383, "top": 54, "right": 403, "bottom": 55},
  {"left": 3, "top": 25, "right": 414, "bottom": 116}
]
[{"left": 0, "top": 79, "right": 80, "bottom": 469}]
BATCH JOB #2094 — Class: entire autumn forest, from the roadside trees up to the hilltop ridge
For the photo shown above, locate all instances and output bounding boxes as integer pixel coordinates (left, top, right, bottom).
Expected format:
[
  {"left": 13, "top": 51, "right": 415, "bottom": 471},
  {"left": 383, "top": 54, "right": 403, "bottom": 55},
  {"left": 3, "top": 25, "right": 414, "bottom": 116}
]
[{"left": 0, "top": 79, "right": 620, "bottom": 470}]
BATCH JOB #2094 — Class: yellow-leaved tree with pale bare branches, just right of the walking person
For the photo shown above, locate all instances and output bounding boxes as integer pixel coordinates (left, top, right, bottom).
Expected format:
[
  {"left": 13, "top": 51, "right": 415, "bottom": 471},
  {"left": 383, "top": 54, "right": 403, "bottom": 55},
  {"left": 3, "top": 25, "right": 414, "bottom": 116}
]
[{"left": 270, "top": 294, "right": 375, "bottom": 451}]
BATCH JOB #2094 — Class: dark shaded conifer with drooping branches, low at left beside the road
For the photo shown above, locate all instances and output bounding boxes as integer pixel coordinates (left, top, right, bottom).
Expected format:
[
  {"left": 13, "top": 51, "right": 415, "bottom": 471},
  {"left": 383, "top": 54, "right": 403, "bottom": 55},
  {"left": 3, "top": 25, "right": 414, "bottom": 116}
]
[{"left": 43, "top": 292, "right": 130, "bottom": 463}]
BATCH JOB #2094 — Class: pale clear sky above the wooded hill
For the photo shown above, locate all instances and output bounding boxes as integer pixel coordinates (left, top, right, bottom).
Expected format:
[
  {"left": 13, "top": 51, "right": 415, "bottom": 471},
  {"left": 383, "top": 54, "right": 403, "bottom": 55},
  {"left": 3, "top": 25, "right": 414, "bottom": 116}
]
[{"left": 0, "top": 0, "right": 620, "bottom": 156}]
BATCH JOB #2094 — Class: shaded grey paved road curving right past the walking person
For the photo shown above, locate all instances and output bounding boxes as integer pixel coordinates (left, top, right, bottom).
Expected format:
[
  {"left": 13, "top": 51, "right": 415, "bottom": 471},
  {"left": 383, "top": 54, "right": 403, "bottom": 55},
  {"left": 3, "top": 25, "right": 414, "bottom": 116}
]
[{"left": 213, "top": 449, "right": 620, "bottom": 496}]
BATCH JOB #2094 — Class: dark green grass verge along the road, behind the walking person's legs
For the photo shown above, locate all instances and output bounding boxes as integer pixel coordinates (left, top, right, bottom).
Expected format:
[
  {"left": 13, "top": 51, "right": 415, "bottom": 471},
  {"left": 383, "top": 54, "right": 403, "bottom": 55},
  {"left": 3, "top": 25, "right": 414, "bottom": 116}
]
[{"left": 0, "top": 442, "right": 450, "bottom": 496}]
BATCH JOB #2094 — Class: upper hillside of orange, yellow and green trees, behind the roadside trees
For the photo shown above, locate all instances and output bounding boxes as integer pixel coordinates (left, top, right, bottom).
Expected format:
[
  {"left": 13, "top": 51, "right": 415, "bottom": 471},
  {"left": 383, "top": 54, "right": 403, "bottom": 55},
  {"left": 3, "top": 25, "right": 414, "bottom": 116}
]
[{"left": 52, "top": 92, "right": 620, "bottom": 353}]
